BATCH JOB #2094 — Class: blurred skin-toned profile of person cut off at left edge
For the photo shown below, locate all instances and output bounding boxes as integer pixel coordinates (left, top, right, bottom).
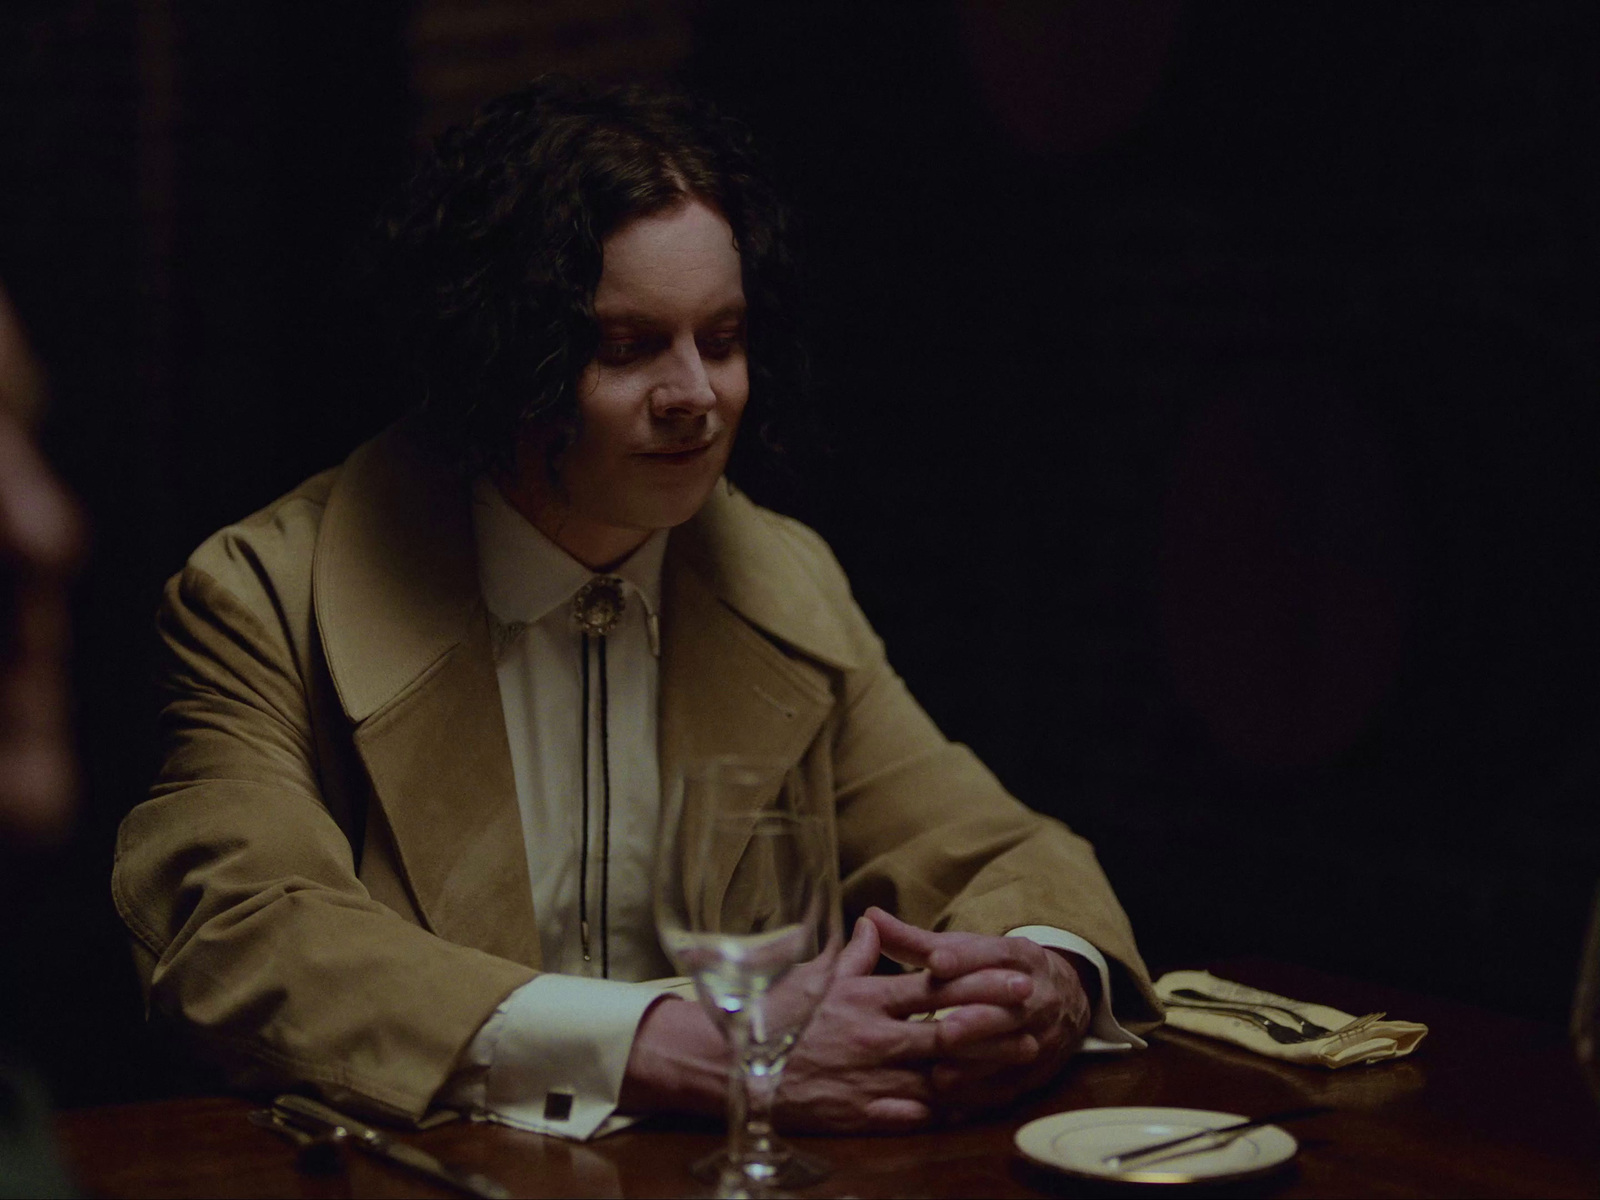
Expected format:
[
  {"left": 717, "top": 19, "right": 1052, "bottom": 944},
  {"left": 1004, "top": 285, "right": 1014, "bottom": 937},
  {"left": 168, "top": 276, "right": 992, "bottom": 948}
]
[{"left": 0, "top": 294, "right": 82, "bottom": 843}]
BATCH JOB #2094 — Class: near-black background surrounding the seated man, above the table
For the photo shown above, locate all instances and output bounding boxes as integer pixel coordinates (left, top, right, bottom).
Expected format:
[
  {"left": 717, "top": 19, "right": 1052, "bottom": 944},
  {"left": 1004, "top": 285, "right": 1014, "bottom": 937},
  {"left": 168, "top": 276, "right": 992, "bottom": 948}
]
[{"left": 0, "top": 0, "right": 1600, "bottom": 1104}]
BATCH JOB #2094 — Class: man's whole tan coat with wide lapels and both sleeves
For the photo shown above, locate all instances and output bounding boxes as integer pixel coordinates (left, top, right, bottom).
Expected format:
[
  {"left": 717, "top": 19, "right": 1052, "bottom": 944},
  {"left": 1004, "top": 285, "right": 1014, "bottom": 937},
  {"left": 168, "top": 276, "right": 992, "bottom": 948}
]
[{"left": 112, "top": 427, "right": 1154, "bottom": 1120}]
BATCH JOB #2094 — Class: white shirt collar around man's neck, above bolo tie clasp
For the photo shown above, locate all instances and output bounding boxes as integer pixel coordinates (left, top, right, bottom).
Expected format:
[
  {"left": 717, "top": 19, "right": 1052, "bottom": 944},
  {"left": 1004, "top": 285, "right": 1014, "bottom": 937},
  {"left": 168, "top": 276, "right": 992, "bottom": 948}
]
[{"left": 472, "top": 478, "right": 667, "bottom": 624}]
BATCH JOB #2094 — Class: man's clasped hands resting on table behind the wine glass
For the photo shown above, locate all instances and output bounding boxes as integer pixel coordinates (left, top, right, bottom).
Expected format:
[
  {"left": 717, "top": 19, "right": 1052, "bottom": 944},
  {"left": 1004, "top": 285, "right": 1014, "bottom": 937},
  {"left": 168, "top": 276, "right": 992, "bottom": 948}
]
[{"left": 622, "top": 909, "right": 1098, "bottom": 1133}]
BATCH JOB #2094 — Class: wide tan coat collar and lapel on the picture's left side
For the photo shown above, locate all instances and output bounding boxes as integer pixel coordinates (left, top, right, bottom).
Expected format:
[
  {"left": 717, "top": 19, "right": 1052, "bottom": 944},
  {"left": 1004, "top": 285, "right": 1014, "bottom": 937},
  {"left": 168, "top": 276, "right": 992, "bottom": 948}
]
[{"left": 312, "top": 426, "right": 539, "bottom": 966}]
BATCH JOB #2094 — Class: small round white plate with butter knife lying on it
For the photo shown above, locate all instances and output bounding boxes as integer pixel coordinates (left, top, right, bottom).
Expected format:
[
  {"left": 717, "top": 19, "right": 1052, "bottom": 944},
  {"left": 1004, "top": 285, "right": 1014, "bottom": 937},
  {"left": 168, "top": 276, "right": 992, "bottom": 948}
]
[{"left": 1016, "top": 1109, "right": 1299, "bottom": 1184}]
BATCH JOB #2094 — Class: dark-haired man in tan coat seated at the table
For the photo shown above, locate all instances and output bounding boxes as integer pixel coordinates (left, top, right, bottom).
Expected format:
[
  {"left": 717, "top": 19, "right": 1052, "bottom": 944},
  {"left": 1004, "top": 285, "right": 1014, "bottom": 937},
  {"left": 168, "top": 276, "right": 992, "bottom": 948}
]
[{"left": 114, "top": 85, "right": 1154, "bottom": 1136}]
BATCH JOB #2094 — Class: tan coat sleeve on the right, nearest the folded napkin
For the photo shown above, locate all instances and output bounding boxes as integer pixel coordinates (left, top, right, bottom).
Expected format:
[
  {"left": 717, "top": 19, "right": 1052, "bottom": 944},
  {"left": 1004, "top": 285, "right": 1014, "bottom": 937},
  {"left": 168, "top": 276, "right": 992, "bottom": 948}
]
[{"left": 811, "top": 534, "right": 1160, "bottom": 1029}]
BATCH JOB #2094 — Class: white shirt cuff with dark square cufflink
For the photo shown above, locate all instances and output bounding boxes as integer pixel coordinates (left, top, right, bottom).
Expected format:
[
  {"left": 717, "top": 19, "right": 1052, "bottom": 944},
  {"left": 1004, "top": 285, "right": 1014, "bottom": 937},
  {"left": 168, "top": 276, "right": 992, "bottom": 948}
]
[{"left": 438, "top": 974, "right": 674, "bottom": 1141}]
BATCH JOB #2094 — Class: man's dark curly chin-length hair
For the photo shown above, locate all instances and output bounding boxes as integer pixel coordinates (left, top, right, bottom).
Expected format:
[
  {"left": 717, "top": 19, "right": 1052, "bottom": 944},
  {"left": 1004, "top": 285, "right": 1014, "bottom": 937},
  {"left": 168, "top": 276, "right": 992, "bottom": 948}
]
[{"left": 374, "top": 77, "right": 806, "bottom": 489}]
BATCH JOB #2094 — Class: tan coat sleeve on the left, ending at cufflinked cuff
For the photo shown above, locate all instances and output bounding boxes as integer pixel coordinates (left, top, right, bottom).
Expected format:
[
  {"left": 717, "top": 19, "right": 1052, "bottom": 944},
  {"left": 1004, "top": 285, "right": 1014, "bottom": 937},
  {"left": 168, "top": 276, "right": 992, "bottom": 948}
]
[{"left": 112, "top": 565, "right": 534, "bottom": 1120}]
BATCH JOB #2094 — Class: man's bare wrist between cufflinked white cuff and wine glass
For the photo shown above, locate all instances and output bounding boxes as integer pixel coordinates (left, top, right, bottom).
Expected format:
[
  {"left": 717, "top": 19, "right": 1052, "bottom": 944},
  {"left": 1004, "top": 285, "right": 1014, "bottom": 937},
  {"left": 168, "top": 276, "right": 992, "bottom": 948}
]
[{"left": 618, "top": 995, "right": 728, "bottom": 1115}]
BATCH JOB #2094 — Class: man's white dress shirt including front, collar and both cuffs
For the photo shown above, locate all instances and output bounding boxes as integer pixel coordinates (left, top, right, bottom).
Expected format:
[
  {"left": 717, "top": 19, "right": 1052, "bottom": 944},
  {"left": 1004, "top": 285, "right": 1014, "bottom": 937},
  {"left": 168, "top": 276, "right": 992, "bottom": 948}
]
[{"left": 440, "top": 482, "right": 1144, "bottom": 1139}]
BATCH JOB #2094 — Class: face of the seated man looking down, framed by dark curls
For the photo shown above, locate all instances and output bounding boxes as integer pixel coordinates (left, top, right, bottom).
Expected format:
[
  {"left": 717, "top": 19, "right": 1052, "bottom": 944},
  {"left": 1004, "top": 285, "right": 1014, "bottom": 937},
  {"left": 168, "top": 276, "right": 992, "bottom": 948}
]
[{"left": 512, "top": 200, "right": 750, "bottom": 568}]
